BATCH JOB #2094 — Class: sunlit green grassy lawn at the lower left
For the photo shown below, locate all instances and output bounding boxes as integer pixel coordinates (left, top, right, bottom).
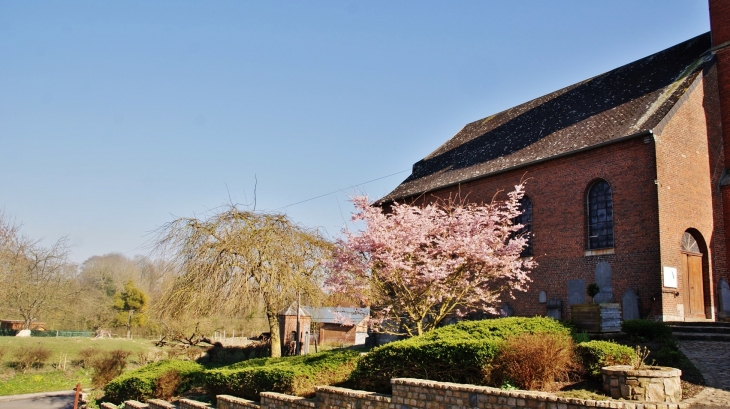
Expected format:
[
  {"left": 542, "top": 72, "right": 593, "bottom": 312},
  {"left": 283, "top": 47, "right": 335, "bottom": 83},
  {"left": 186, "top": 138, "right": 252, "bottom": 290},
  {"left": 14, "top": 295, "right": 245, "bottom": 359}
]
[{"left": 0, "top": 337, "right": 162, "bottom": 396}]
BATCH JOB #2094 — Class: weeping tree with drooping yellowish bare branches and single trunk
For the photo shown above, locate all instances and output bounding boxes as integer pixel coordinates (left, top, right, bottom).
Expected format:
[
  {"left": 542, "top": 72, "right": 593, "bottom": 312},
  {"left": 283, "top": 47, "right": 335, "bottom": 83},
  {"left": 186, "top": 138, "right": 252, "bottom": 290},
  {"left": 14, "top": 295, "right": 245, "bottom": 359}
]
[{"left": 155, "top": 206, "right": 330, "bottom": 357}]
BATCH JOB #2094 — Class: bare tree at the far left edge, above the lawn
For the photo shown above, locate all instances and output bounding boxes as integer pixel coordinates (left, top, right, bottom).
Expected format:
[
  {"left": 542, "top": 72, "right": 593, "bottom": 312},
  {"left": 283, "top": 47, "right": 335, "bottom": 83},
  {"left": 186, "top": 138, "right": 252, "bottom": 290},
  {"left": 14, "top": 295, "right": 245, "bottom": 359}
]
[{"left": 0, "top": 214, "right": 76, "bottom": 329}]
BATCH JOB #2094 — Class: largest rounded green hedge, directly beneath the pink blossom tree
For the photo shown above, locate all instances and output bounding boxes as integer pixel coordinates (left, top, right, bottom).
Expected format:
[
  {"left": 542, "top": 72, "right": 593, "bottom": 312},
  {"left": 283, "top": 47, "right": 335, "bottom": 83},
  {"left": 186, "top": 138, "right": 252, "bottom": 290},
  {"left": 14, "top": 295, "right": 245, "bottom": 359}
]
[{"left": 347, "top": 317, "right": 570, "bottom": 393}]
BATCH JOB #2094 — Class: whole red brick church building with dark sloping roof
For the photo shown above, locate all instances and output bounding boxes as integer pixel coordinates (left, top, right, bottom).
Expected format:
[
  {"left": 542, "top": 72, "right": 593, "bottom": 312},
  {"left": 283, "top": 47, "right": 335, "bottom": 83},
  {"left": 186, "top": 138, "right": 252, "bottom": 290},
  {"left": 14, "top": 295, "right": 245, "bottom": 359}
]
[{"left": 380, "top": 0, "right": 730, "bottom": 321}]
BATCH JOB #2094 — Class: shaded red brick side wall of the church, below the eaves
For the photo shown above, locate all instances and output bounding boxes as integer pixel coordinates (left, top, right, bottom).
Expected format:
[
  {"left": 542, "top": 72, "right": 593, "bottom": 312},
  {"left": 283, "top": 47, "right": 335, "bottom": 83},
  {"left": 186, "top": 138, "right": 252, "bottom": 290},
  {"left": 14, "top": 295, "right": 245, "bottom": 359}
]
[{"left": 410, "top": 136, "right": 662, "bottom": 317}]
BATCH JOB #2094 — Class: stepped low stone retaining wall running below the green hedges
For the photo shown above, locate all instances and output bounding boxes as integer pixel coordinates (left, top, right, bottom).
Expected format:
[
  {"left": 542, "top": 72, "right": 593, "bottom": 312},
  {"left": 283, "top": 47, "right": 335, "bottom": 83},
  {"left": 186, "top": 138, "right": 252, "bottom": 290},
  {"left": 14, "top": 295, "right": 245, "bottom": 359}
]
[{"left": 105, "top": 378, "right": 697, "bottom": 409}]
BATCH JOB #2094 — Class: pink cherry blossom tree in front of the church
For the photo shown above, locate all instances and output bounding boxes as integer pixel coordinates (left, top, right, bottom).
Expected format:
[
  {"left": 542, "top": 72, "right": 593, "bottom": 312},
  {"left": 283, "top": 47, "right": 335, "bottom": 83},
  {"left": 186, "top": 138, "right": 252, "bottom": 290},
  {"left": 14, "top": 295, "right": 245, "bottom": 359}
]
[{"left": 326, "top": 184, "right": 535, "bottom": 336}]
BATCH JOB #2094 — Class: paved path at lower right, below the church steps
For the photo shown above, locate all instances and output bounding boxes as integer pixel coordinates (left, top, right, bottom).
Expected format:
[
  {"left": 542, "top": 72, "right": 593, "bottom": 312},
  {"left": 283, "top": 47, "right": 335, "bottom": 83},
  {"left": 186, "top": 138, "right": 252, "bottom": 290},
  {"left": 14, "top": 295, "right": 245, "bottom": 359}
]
[{"left": 672, "top": 341, "right": 730, "bottom": 409}]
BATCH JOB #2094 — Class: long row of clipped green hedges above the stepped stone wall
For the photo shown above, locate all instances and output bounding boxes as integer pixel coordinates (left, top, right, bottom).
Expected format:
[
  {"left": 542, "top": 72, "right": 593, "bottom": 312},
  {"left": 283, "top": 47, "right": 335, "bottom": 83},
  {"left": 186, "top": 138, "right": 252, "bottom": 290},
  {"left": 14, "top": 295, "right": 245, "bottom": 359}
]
[{"left": 105, "top": 317, "right": 596, "bottom": 402}]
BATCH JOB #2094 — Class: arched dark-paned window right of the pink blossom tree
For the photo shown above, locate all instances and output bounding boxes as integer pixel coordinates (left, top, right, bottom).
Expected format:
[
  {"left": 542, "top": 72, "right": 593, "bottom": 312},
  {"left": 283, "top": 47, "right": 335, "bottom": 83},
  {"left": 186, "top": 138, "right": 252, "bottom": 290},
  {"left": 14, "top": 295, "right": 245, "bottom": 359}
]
[{"left": 587, "top": 180, "right": 613, "bottom": 249}]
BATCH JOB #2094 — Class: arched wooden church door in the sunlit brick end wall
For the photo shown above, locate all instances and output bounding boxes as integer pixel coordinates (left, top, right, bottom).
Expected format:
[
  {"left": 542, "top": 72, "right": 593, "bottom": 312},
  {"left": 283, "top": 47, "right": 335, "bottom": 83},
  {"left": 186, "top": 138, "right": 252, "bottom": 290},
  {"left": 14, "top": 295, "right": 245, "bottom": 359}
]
[{"left": 682, "top": 233, "right": 706, "bottom": 319}]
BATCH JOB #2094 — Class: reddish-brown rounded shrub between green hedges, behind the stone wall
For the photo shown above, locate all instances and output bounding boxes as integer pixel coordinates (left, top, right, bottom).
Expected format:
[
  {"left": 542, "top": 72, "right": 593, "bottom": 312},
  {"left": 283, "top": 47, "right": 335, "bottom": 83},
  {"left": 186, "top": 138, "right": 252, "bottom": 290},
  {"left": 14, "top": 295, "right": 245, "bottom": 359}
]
[{"left": 490, "top": 334, "right": 580, "bottom": 390}]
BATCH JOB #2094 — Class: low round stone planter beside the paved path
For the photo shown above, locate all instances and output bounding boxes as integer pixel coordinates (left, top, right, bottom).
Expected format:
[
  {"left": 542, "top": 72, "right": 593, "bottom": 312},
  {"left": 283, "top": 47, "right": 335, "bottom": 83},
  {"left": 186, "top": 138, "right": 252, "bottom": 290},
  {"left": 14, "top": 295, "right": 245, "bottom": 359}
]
[{"left": 601, "top": 365, "right": 682, "bottom": 403}]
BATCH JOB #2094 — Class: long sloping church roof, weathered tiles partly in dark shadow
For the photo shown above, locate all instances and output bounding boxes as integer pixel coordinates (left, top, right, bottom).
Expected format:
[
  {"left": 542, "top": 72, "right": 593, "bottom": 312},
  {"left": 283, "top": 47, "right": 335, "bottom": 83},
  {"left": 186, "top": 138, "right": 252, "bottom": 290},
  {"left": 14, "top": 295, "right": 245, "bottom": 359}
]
[{"left": 379, "top": 33, "right": 711, "bottom": 203}]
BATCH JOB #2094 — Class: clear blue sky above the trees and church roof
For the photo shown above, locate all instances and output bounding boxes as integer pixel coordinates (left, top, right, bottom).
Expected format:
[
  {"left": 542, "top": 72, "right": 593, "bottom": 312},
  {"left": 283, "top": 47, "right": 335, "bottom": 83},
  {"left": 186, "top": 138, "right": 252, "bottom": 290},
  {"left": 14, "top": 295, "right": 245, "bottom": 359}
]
[{"left": 0, "top": 0, "right": 709, "bottom": 262}]
